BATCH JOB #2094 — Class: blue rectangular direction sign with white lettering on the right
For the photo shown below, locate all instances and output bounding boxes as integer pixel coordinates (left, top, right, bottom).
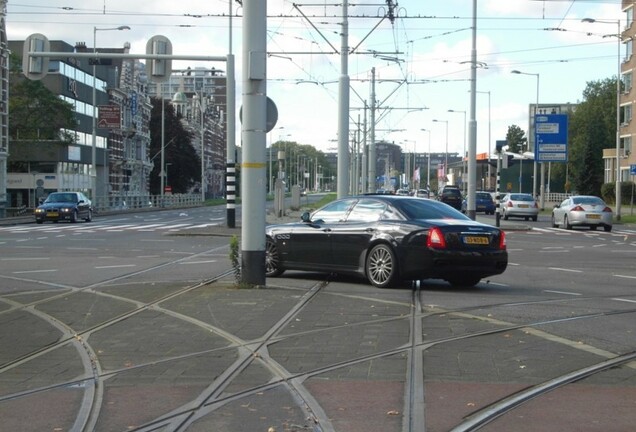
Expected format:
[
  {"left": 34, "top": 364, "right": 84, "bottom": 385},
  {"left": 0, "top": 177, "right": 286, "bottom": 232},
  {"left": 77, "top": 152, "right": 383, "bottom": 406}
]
[{"left": 534, "top": 114, "right": 568, "bottom": 162}]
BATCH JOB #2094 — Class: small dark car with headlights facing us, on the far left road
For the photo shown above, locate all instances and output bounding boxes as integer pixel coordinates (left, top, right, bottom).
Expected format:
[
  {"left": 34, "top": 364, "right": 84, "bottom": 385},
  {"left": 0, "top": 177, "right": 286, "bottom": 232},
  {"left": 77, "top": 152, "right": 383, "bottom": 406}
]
[{"left": 35, "top": 192, "right": 93, "bottom": 224}]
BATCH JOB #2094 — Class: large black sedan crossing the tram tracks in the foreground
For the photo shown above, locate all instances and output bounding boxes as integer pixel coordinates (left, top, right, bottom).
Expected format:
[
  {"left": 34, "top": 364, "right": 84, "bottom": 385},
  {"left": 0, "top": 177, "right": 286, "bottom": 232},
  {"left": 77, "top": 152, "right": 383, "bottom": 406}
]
[{"left": 265, "top": 195, "right": 508, "bottom": 287}]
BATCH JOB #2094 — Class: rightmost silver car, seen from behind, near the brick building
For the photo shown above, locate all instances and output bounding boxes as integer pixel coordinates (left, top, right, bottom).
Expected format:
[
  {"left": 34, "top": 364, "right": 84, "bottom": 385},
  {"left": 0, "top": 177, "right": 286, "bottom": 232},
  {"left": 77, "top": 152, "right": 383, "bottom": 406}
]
[{"left": 552, "top": 195, "right": 613, "bottom": 232}]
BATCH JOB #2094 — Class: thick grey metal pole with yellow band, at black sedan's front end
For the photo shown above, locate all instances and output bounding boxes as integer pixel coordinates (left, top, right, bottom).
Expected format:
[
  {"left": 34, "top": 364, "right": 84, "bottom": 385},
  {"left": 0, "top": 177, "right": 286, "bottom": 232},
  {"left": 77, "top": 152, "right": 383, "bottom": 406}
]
[{"left": 241, "top": 0, "right": 267, "bottom": 285}]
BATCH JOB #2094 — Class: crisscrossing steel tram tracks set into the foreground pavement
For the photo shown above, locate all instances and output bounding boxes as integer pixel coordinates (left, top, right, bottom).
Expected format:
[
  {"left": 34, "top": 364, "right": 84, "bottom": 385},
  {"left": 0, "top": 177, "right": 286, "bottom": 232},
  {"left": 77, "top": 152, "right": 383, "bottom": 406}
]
[{"left": 0, "top": 270, "right": 636, "bottom": 432}]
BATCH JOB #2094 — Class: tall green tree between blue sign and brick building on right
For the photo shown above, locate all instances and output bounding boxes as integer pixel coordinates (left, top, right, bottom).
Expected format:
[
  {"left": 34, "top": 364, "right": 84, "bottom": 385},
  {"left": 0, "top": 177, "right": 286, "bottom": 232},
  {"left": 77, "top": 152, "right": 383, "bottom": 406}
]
[{"left": 569, "top": 79, "right": 616, "bottom": 196}]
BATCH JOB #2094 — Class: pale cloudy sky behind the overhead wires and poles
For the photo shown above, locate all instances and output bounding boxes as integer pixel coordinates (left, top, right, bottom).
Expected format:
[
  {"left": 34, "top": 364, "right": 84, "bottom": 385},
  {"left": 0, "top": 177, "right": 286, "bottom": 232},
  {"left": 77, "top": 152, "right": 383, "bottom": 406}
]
[{"left": 6, "top": 0, "right": 625, "bottom": 153}]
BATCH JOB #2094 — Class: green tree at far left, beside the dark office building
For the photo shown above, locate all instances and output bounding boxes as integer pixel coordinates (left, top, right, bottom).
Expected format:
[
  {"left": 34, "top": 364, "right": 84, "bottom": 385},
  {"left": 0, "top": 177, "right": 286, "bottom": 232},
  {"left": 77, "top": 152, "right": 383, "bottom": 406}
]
[{"left": 9, "top": 54, "right": 77, "bottom": 143}]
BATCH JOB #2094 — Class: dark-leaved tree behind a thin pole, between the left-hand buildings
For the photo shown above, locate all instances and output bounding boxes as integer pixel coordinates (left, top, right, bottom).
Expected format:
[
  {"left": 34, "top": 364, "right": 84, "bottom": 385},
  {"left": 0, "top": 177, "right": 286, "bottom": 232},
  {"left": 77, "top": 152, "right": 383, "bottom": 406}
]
[{"left": 150, "top": 98, "right": 201, "bottom": 194}]
